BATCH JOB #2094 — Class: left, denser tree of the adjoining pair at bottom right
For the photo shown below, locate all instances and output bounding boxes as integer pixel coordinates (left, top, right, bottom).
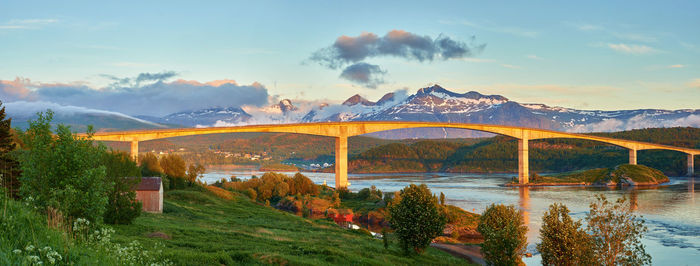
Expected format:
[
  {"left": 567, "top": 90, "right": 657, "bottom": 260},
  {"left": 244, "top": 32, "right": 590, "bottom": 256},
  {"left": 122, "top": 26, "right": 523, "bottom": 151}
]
[{"left": 537, "top": 203, "right": 595, "bottom": 265}]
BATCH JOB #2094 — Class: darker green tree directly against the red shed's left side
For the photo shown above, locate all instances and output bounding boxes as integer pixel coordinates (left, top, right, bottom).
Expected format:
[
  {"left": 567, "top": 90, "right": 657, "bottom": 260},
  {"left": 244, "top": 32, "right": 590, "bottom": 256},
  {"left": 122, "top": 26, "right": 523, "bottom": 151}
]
[{"left": 102, "top": 151, "right": 141, "bottom": 224}]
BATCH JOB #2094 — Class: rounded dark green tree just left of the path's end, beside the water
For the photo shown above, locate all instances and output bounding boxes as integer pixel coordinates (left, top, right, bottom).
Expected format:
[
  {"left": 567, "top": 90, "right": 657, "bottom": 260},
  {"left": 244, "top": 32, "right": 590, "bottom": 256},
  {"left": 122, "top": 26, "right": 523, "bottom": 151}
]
[{"left": 388, "top": 184, "right": 446, "bottom": 253}]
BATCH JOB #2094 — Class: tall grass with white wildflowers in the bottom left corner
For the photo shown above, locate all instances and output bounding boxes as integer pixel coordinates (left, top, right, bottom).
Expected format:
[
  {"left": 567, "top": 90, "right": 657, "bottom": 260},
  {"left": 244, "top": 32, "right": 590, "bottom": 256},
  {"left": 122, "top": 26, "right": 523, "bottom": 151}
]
[{"left": 0, "top": 190, "right": 168, "bottom": 265}]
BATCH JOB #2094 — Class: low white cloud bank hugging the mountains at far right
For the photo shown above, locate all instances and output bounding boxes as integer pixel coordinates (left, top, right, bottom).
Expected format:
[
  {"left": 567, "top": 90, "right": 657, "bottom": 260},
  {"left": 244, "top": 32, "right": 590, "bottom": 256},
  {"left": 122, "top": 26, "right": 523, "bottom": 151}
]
[{"left": 569, "top": 114, "right": 700, "bottom": 133}]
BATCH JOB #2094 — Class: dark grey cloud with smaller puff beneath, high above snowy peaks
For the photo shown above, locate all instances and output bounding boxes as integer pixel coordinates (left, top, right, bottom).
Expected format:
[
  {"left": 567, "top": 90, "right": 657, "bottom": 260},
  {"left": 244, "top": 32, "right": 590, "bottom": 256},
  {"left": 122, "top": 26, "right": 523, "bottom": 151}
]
[{"left": 309, "top": 30, "right": 486, "bottom": 88}]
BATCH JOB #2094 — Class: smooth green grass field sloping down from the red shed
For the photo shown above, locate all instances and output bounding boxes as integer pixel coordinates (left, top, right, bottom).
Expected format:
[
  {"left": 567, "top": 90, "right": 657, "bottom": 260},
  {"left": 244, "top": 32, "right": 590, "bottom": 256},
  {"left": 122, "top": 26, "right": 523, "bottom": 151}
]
[{"left": 114, "top": 188, "right": 467, "bottom": 265}]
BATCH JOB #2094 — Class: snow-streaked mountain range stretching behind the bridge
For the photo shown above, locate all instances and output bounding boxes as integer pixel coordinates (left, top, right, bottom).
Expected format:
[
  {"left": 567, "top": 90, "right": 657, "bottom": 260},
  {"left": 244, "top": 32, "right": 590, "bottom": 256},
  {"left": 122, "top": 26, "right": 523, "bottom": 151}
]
[{"left": 8, "top": 85, "right": 700, "bottom": 138}]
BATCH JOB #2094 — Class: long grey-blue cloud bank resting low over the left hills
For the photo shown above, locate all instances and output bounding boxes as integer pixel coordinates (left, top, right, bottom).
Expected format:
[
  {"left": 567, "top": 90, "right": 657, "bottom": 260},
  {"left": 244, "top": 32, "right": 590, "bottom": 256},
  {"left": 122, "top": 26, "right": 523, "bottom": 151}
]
[{"left": 0, "top": 72, "right": 269, "bottom": 116}]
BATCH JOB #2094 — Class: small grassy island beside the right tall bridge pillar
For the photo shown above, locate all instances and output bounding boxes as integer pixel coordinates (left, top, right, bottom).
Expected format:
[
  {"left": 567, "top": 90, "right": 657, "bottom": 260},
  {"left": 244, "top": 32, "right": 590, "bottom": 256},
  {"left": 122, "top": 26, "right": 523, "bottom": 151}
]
[{"left": 506, "top": 164, "right": 669, "bottom": 187}]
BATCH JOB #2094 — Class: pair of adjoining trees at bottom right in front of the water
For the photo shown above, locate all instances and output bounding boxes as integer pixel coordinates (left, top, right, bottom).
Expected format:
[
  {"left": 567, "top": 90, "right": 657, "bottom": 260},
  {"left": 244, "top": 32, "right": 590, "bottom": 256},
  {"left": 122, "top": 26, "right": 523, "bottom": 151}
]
[{"left": 537, "top": 195, "right": 651, "bottom": 265}]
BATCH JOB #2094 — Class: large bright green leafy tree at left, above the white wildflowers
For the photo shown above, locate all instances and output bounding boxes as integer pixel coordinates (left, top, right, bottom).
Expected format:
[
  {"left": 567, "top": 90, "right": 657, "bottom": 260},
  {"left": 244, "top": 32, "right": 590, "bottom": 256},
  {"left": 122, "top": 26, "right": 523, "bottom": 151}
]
[{"left": 18, "top": 110, "right": 111, "bottom": 222}]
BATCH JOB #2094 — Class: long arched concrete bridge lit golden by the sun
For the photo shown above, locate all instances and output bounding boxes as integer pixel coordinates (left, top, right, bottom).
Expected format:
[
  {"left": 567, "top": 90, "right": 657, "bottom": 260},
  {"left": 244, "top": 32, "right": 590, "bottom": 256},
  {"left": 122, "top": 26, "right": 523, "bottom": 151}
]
[{"left": 82, "top": 121, "right": 700, "bottom": 188}]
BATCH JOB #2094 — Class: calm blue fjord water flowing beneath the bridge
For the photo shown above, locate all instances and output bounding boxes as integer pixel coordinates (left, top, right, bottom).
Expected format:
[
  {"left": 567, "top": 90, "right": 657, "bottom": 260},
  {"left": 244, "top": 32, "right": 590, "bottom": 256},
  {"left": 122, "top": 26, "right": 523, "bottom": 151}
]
[{"left": 204, "top": 167, "right": 700, "bottom": 265}]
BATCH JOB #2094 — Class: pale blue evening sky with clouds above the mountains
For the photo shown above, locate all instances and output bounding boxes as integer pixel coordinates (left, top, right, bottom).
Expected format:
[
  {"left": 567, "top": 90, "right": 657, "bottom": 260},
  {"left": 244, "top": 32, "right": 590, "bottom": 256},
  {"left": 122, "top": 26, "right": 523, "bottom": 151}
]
[{"left": 0, "top": 0, "right": 700, "bottom": 116}]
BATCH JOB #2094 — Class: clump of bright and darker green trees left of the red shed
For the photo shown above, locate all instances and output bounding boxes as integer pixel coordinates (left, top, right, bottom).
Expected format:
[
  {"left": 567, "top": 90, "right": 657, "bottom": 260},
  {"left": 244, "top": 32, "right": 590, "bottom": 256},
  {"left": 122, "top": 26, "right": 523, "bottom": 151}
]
[{"left": 17, "top": 110, "right": 141, "bottom": 223}]
